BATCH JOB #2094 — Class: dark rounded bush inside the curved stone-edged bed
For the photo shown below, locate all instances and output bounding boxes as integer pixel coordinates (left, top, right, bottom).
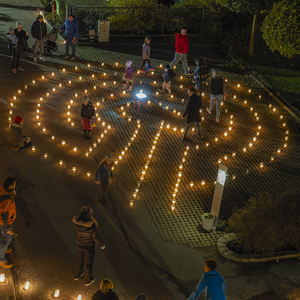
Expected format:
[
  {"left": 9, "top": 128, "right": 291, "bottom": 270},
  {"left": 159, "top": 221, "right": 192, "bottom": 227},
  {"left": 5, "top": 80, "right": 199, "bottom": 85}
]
[{"left": 228, "top": 190, "right": 300, "bottom": 254}]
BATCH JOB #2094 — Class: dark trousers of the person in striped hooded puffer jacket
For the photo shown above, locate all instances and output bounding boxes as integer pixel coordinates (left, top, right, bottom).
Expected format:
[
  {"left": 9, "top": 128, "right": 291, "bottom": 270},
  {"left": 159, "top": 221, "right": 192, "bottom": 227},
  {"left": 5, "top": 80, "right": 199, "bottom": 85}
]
[{"left": 74, "top": 245, "right": 95, "bottom": 283}]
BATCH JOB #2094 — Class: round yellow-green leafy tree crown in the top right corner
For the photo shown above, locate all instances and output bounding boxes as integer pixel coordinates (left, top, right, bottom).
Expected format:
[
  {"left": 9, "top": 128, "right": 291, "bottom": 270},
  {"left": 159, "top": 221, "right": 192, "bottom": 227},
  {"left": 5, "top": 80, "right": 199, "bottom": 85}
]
[{"left": 262, "top": 0, "right": 300, "bottom": 57}]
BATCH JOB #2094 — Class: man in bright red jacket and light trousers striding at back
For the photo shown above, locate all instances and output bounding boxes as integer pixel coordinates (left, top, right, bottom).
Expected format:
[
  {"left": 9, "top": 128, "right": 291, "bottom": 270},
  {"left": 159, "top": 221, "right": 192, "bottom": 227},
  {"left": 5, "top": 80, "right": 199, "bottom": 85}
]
[{"left": 170, "top": 29, "right": 193, "bottom": 75}]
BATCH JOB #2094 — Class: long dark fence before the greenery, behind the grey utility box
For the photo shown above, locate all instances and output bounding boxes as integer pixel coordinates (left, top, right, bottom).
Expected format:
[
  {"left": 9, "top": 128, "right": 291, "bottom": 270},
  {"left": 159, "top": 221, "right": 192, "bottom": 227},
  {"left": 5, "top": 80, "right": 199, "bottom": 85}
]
[{"left": 67, "top": 5, "right": 204, "bottom": 37}]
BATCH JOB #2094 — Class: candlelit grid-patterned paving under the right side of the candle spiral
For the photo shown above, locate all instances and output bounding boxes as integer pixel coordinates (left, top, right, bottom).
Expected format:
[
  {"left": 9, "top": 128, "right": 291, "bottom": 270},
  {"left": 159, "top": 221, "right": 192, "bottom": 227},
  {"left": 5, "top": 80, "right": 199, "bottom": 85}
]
[{"left": 74, "top": 48, "right": 300, "bottom": 248}]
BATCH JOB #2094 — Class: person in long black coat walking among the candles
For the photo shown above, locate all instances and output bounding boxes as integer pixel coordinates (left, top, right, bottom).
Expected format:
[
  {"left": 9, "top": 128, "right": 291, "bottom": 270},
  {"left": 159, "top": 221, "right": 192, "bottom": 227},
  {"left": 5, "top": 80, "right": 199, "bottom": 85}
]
[{"left": 182, "top": 87, "right": 202, "bottom": 140}]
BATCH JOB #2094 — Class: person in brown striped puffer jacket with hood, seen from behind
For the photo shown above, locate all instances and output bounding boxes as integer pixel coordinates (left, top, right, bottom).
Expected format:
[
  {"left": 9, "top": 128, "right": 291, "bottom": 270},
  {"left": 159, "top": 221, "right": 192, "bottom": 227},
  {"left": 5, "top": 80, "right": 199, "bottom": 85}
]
[{"left": 72, "top": 206, "right": 105, "bottom": 286}]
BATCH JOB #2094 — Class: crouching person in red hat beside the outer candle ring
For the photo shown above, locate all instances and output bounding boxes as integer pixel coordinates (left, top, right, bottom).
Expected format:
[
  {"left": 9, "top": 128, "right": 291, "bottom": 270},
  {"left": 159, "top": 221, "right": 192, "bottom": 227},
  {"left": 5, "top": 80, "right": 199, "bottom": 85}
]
[{"left": 10, "top": 116, "right": 31, "bottom": 150}]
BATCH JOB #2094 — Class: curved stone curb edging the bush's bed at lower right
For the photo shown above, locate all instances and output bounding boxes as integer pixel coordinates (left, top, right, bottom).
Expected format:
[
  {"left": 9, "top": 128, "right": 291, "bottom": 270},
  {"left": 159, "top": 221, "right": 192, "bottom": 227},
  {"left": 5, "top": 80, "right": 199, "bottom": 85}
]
[{"left": 217, "top": 233, "right": 300, "bottom": 263}]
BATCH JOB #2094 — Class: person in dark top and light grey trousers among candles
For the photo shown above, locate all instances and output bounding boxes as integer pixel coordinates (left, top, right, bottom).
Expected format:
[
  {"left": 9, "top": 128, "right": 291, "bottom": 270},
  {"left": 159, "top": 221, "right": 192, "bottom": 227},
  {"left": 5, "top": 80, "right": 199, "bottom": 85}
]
[{"left": 206, "top": 68, "right": 225, "bottom": 122}]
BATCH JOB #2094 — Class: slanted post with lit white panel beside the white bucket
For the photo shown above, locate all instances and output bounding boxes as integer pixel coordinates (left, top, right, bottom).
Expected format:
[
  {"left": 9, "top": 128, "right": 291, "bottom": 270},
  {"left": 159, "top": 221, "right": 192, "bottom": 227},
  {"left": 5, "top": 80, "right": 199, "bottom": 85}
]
[{"left": 210, "top": 164, "right": 228, "bottom": 229}]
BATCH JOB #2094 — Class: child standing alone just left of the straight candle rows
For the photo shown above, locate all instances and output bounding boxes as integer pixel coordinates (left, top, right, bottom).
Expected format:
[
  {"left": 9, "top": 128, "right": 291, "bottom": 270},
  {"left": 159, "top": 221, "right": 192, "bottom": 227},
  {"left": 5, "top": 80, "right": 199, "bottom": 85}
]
[{"left": 95, "top": 153, "right": 114, "bottom": 204}]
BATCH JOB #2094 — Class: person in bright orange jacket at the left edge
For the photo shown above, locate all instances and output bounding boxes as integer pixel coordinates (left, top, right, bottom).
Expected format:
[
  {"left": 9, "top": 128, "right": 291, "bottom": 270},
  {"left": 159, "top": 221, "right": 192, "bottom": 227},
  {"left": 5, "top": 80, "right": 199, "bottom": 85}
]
[{"left": 0, "top": 177, "right": 17, "bottom": 269}]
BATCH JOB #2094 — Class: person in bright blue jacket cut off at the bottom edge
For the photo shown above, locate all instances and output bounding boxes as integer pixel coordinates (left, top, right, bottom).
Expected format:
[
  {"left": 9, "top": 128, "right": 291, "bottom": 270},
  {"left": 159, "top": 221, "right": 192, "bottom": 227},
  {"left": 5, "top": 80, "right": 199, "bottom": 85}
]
[{"left": 188, "top": 259, "right": 226, "bottom": 300}]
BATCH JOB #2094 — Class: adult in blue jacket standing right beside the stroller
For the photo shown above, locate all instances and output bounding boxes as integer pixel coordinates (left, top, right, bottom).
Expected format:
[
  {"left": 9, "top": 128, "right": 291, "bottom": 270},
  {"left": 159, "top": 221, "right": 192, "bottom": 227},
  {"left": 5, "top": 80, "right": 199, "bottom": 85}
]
[{"left": 58, "top": 15, "right": 79, "bottom": 61}]
